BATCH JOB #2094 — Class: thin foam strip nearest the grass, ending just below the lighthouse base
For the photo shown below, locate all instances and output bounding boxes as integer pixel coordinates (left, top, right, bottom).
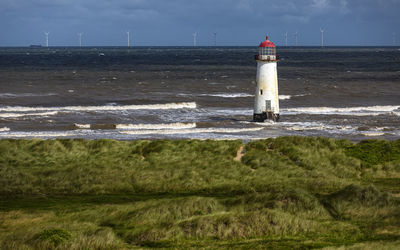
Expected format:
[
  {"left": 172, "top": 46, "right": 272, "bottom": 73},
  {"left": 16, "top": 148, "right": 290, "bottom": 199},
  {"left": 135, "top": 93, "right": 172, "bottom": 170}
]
[{"left": 120, "top": 128, "right": 263, "bottom": 135}]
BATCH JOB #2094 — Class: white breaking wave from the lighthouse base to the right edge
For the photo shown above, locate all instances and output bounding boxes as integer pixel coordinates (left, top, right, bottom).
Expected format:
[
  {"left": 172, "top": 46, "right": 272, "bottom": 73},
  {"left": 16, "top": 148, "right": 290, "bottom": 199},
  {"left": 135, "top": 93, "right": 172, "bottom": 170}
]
[{"left": 281, "top": 106, "right": 400, "bottom": 116}]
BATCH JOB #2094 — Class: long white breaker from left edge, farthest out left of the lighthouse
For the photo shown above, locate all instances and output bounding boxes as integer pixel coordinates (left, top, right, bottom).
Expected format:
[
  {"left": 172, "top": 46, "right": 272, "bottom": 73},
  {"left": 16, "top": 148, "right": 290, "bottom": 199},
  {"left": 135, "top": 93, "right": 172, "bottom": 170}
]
[{"left": 0, "top": 102, "right": 197, "bottom": 112}]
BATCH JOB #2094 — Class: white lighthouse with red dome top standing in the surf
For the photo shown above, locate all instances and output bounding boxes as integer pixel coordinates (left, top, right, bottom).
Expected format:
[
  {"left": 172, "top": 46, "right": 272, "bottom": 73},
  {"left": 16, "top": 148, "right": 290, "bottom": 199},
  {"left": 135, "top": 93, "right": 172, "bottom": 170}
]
[{"left": 253, "top": 36, "right": 279, "bottom": 122}]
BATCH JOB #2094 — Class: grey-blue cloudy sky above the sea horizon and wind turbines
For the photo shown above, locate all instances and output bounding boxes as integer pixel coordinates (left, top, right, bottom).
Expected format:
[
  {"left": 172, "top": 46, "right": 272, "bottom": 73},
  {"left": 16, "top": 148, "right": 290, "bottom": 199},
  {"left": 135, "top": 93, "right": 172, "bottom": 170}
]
[{"left": 0, "top": 0, "right": 400, "bottom": 46}]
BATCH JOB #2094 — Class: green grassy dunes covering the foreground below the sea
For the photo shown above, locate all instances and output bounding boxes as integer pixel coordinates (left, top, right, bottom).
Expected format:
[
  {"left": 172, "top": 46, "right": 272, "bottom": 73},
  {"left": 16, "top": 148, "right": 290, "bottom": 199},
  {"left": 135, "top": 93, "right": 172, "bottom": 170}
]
[{"left": 0, "top": 137, "right": 400, "bottom": 249}]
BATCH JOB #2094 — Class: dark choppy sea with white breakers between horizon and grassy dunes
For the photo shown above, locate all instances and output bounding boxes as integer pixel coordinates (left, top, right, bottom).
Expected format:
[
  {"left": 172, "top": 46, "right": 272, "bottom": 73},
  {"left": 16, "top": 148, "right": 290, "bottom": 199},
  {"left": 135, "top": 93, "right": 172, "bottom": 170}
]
[{"left": 0, "top": 46, "right": 400, "bottom": 141}]
